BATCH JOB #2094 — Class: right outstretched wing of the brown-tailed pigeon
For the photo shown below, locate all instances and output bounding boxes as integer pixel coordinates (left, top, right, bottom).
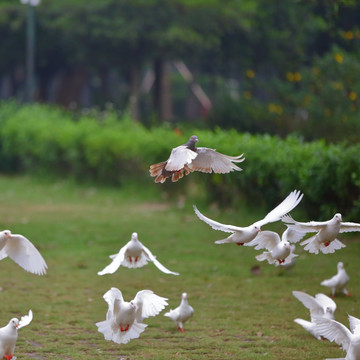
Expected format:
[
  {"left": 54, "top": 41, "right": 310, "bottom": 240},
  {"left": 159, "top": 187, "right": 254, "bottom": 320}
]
[{"left": 189, "top": 147, "right": 245, "bottom": 174}]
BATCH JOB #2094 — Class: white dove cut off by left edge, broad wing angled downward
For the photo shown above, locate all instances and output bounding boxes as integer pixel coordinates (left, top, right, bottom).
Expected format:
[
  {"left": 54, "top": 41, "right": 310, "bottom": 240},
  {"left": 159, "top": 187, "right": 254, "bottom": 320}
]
[{"left": 0, "top": 230, "right": 47, "bottom": 275}]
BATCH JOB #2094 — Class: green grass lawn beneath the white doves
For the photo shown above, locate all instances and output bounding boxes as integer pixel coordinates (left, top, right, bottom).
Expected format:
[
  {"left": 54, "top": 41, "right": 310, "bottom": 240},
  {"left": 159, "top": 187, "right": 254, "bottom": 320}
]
[{"left": 0, "top": 176, "right": 360, "bottom": 360}]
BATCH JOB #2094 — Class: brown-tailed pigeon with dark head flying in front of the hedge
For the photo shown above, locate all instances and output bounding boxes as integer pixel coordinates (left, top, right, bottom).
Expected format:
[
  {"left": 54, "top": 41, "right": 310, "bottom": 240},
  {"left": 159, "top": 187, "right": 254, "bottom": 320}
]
[{"left": 149, "top": 135, "right": 245, "bottom": 183}]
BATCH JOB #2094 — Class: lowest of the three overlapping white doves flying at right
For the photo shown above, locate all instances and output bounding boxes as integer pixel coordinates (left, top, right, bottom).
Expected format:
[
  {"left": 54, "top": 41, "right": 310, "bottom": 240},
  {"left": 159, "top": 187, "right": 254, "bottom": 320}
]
[{"left": 249, "top": 228, "right": 303, "bottom": 266}]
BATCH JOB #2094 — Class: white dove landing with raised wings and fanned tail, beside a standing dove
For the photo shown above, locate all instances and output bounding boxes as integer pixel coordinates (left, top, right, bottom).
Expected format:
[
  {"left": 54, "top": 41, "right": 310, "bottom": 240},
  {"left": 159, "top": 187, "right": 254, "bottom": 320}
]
[{"left": 96, "top": 288, "right": 168, "bottom": 344}]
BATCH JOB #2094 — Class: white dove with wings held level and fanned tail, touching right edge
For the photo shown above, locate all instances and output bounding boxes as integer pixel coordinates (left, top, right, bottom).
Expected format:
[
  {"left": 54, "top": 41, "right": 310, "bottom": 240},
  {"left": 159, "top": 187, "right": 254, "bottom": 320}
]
[{"left": 281, "top": 213, "right": 360, "bottom": 254}]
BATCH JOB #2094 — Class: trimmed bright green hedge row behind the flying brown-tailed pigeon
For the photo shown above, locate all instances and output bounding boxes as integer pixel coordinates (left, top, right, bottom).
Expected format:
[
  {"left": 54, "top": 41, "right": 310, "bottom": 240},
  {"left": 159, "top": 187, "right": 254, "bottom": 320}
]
[{"left": 0, "top": 102, "right": 360, "bottom": 221}]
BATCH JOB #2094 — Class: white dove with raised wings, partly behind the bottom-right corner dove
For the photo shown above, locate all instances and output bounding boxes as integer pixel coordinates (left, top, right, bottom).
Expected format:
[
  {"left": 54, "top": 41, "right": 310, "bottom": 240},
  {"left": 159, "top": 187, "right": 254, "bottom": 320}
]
[{"left": 292, "top": 291, "right": 336, "bottom": 340}]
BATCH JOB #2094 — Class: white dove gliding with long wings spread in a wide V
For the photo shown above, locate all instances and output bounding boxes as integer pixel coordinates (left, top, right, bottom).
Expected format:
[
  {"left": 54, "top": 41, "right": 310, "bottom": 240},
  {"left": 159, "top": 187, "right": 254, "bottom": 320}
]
[{"left": 194, "top": 190, "right": 303, "bottom": 245}]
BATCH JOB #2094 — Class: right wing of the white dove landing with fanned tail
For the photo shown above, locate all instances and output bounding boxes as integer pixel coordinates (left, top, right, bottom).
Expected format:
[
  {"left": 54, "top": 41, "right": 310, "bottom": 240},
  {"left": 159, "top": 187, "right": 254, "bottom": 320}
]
[{"left": 133, "top": 290, "right": 168, "bottom": 323}]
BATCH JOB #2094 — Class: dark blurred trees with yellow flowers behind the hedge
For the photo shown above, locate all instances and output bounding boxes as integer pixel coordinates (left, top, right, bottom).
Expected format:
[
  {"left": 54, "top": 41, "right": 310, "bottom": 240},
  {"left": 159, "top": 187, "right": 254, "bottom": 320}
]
[{"left": 0, "top": 0, "right": 360, "bottom": 142}]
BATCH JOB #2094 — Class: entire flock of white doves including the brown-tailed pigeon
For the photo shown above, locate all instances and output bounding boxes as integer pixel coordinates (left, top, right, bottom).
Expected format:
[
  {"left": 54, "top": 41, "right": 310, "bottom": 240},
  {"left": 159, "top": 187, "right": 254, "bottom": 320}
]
[{"left": 0, "top": 135, "right": 360, "bottom": 360}]
